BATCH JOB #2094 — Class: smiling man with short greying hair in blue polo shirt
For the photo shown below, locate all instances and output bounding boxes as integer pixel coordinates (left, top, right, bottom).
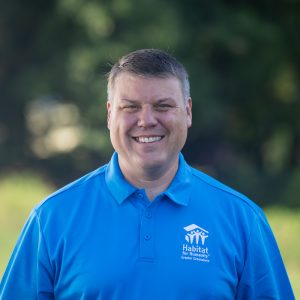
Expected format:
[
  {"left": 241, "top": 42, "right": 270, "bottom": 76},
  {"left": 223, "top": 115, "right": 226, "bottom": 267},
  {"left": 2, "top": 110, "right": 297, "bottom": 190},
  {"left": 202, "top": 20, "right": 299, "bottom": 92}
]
[{"left": 0, "top": 49, "right": 294, "bottom": 300}]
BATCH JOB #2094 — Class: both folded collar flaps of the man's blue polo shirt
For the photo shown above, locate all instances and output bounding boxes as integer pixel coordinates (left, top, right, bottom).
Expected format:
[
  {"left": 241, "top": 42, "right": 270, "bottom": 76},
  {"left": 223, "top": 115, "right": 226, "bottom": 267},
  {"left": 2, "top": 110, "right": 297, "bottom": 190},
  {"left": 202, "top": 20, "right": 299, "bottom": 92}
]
[{"left": 105, "top": 152, "right": 192, "bottom": 206}]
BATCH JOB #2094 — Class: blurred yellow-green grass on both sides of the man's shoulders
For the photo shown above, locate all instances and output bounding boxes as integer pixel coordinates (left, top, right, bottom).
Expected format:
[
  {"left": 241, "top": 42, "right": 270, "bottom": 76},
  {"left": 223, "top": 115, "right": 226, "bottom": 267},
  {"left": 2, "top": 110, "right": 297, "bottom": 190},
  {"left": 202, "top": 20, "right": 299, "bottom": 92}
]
[{"left": 0, "top": 172, "right": 300, "bottom": 299}]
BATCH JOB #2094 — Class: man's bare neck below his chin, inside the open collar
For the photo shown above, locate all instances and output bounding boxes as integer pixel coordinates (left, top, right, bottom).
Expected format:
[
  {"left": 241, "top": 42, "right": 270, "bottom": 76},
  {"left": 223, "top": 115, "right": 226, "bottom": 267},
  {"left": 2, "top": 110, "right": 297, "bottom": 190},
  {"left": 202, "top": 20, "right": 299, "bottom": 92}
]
[{"left": 119, "top": 160, "right": 178, "bottom": 201}]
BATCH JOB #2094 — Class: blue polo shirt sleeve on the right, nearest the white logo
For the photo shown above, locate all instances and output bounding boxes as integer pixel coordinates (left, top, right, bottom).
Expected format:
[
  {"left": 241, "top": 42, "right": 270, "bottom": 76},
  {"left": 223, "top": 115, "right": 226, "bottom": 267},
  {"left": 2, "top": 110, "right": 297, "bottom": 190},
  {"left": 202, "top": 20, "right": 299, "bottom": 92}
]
[{"left": 236, "top": 211, "right": 295, "bottom": 300}]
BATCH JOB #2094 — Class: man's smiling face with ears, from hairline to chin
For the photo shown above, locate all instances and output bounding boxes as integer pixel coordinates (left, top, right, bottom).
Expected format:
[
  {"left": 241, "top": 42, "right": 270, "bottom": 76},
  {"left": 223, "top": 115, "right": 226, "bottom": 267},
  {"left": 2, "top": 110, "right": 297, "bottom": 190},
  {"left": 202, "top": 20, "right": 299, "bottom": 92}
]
[{"left": 107, "top": 72, "right": 192, "bottom": 176}]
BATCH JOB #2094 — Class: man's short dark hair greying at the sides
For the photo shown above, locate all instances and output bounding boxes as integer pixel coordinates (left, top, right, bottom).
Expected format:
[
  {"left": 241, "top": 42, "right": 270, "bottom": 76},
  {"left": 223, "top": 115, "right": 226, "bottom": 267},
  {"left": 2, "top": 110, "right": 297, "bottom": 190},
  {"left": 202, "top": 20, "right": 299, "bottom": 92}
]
[{"left": 107, "top": 49, "right": 190, "bottom": 103}]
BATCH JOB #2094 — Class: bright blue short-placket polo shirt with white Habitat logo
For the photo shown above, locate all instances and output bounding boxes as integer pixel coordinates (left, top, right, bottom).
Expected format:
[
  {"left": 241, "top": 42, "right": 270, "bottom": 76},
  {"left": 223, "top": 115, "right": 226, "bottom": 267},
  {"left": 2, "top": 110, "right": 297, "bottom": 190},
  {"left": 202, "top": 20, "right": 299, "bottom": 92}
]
[{"left": 0, "top": 153, "right": 294, "bottom": 300}]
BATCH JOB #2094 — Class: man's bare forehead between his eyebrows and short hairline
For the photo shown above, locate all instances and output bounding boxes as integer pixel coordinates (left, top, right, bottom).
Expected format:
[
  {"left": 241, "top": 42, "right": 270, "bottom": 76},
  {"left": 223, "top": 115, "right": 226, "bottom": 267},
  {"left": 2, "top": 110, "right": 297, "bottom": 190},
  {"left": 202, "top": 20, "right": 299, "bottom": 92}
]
[{"left": 114, "top": 72, "right": 183, "bottom": 100}]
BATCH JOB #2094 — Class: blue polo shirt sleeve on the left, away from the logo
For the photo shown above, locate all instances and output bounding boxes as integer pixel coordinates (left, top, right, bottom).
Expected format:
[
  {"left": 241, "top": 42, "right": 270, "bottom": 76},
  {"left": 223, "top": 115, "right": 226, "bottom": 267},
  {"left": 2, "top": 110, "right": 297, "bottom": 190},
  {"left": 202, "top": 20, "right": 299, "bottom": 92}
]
[{"left": 0, "top": 210, "right": 54, "bottom": 300}]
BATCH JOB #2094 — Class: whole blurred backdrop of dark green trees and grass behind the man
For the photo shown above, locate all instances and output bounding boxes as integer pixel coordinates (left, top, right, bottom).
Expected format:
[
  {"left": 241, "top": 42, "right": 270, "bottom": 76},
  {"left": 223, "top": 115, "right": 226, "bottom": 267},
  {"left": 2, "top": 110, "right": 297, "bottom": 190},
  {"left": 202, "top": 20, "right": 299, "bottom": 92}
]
[{"left": 0, "top": 0, "right": 300, "bottom": 296}]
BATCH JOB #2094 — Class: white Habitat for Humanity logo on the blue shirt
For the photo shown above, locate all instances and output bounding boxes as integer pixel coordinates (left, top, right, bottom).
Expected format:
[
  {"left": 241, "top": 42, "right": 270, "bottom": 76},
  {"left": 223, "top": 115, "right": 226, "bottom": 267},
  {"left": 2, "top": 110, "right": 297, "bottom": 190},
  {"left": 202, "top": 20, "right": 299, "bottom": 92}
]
[{"left": 181, "top": 224, "right": 210, "bottom": 262}]
